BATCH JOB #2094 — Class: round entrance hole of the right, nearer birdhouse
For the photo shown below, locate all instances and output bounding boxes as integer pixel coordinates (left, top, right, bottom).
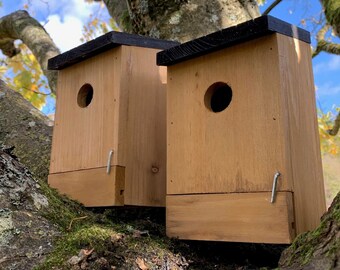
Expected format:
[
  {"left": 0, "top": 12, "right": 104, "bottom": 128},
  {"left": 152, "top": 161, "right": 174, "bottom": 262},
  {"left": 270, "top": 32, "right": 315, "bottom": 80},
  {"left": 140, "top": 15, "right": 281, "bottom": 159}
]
[{"left": 204, "top": 82, "right": 233, "bottom": 113}]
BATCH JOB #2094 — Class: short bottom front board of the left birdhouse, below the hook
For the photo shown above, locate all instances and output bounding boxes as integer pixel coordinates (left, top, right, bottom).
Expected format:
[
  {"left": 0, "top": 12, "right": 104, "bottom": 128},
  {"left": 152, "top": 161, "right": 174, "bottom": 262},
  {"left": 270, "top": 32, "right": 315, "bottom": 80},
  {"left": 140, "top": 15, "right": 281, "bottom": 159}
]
[{"left": 48, "top": 166, "right": 125, "bottom": 207}]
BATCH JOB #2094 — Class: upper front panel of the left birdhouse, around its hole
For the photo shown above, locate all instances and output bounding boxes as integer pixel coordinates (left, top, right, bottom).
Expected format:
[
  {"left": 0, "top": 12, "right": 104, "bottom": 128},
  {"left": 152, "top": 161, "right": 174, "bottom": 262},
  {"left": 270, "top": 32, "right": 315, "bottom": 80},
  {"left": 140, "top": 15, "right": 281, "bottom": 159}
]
[{"left": 50, "top": 48, "right": 124, "bottom": 173}]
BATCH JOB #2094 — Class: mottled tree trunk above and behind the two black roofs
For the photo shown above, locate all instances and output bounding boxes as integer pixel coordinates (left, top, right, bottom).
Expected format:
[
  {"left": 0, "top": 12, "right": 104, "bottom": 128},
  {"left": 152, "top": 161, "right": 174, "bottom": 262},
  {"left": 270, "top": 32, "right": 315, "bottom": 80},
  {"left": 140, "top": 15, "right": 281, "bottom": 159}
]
[{"left": 104, "top": 0, "right": 260, "bottom": 42}]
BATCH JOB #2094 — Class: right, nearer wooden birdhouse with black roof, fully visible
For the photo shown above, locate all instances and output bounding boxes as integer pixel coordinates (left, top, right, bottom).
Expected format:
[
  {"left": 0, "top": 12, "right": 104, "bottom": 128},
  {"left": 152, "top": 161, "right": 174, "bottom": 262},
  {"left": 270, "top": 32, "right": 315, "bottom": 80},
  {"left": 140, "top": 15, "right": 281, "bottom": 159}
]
[{"left": 157, "top": 16, "right": 326, "bottom": 243}]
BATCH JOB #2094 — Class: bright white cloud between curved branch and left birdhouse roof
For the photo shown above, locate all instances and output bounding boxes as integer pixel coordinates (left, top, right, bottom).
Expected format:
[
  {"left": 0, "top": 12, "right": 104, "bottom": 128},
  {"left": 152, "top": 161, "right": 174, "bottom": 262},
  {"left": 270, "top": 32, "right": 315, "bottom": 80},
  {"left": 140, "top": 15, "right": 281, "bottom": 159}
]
[{"left": 45, "top": 14, "right": 83, "bottom": 52}]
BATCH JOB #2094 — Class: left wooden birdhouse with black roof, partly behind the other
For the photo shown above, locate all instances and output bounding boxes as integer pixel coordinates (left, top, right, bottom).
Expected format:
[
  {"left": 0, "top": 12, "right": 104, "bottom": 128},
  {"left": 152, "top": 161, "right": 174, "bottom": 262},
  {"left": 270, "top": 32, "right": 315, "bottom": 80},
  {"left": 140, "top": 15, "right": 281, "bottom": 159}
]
[{"left": 48, "top": 32, "right": 178, "bottom": 206}]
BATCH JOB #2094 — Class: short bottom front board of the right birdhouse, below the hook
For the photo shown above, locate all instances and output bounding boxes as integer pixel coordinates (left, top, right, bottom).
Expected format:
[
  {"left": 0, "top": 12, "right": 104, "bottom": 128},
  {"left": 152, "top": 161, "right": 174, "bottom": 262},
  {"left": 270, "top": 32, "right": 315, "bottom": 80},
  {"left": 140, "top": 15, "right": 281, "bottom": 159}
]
[{"left": 166, "top": 192, "right": 295, "bottom": 244}]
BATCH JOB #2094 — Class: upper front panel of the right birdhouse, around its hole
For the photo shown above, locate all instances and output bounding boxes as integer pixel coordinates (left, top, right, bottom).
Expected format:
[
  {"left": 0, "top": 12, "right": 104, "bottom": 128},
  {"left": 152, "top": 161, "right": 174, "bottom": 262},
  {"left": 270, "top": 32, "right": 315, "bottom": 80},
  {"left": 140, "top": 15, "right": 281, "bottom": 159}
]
[{"left": 167, "top": 35, "right": 292, "bottom": 194}]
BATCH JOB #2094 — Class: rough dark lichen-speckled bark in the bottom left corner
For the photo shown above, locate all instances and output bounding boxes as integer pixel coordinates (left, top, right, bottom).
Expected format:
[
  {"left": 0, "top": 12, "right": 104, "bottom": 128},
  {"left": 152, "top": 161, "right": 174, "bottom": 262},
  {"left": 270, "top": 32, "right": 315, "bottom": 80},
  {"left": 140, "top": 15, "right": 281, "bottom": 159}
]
[{"left": 0, "top": 148, "right": 60, "bottom": 270}]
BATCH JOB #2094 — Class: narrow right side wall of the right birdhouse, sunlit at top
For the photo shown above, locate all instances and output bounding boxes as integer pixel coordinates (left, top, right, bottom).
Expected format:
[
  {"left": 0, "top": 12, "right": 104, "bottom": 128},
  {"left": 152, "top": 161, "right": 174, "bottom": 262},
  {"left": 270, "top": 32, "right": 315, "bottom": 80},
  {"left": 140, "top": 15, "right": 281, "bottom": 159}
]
[{"left": 277, "top": 34, "right": 326, "bottom": 233}]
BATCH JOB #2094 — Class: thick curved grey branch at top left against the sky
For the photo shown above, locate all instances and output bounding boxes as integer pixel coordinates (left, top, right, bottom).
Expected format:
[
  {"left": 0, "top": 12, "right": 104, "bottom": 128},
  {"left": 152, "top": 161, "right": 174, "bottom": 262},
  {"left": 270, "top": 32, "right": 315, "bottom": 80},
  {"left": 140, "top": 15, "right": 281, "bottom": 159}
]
[{"left": 0, "top": 10, "right": 60, "bottom": 93}]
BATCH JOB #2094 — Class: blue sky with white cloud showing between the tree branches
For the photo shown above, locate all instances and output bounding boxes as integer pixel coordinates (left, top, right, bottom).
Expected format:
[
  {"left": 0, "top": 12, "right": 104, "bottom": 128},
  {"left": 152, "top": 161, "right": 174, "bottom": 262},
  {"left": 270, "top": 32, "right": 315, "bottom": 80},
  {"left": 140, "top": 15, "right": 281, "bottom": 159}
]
[{"left": 0, "top": 0, "right": 340, "bottom": 113}]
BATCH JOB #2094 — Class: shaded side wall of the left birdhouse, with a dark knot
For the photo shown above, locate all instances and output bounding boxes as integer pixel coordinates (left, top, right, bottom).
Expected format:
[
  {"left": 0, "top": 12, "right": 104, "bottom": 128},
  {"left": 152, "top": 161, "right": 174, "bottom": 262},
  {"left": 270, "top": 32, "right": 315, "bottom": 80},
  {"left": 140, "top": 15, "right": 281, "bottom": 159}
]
[{"left": 119, "top": 46, "right": 166, "bottom": 206}]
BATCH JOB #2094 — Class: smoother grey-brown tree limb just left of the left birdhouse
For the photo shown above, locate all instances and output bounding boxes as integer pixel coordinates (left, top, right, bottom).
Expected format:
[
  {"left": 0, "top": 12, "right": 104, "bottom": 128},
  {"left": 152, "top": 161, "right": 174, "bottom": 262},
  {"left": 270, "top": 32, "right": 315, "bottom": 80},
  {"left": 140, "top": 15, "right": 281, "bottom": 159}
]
[{"left": 0, "top": 80, "right": 52, "bottom": 179}]
